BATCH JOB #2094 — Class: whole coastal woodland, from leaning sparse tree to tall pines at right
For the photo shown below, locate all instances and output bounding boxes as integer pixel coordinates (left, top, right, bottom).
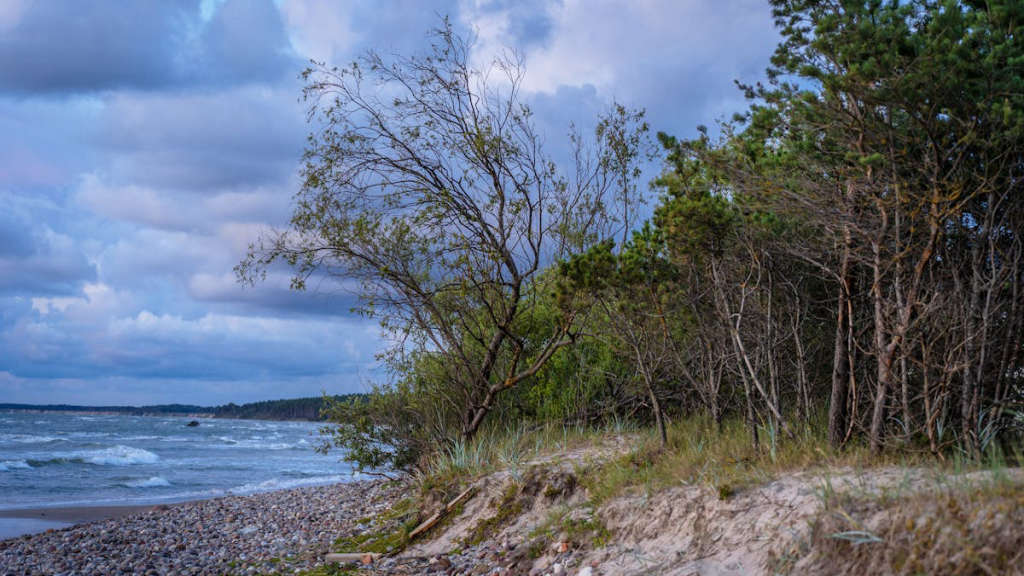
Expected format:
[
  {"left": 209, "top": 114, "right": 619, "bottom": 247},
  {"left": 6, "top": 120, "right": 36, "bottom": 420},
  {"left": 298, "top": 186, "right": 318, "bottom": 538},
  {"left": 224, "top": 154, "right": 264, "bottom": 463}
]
[{"left": 238, "top": 0, "right": 1024, "bottom": 469}]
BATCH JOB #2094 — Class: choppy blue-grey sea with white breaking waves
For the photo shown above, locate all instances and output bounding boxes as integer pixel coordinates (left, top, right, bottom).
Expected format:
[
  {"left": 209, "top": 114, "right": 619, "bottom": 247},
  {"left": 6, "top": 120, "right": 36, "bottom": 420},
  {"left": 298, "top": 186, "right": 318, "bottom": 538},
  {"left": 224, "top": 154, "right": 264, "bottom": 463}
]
[{"left": 0, "top": 412, "right": 353, "bottom": 509}]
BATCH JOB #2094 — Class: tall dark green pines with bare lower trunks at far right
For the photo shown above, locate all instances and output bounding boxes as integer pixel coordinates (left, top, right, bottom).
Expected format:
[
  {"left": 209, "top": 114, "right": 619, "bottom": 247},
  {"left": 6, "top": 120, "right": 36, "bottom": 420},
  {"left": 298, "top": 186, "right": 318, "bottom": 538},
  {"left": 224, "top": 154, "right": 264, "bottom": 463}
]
[{"left": 732, "top": 0, "right": 1024, "bottom": 453}]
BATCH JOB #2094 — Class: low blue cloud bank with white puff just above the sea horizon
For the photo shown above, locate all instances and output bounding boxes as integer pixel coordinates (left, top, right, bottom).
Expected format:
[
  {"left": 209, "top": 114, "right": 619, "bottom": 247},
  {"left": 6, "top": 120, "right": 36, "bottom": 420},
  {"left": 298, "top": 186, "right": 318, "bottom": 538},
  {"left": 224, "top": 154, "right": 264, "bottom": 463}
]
[{"left": 0, "top": 301, "right": 380, "bottom": 380}]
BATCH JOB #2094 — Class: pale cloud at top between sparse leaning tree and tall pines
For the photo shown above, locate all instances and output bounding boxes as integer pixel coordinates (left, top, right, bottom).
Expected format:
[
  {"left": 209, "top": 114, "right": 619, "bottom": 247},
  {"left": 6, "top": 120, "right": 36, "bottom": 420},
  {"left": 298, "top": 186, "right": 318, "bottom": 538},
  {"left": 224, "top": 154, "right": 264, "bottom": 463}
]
[{"left": 462, "top": 0, "right": 777, "bottom": 133}]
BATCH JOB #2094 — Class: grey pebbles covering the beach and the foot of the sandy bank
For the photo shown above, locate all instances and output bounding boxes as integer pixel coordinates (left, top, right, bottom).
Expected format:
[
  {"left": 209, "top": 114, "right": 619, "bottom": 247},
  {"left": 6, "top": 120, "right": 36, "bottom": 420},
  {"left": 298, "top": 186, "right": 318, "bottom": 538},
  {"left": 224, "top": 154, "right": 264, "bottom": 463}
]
[{"left": 0, "top": 481, "right": 591, "bottom": 576}]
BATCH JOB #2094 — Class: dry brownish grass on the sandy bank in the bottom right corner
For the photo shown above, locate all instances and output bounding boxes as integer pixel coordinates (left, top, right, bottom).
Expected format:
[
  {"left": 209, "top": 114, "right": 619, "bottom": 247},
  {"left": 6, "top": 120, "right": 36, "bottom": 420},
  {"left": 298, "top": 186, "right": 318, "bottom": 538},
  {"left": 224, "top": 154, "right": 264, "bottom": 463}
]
[{"left": 772, "top": 475, "right": 1024, "bottom": 575}]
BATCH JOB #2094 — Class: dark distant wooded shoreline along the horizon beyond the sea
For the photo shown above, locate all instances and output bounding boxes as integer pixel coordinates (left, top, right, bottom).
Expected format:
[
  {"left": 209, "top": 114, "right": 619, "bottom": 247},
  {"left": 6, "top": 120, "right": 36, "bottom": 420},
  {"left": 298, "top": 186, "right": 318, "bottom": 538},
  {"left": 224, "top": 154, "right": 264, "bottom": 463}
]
[{"left": 0, "top": 395, "right": 361, "bottom": 421}]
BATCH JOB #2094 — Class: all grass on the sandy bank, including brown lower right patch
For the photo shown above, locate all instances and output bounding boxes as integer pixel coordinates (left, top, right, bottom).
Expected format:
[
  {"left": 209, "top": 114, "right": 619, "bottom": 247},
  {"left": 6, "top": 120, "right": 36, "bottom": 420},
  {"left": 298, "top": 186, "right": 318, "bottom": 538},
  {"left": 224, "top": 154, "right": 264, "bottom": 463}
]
[{"left": 294, "top": 416, "right": 1024, "bottom": 576}]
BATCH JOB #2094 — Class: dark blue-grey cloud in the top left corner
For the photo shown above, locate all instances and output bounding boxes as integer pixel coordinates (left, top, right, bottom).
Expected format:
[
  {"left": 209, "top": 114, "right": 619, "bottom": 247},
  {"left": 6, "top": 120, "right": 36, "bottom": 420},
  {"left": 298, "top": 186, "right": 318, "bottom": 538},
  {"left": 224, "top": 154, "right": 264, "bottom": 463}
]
[{"left": 0, "top": 0, "right": 299, "bottom": 95}]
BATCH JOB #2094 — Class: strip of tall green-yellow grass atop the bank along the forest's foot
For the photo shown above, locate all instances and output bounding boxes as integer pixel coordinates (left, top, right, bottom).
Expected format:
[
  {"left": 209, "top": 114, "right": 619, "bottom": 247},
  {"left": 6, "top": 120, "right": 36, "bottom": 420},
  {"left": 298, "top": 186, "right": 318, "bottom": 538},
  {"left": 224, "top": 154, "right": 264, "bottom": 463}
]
[{"left": 411, "top": 405, "right": 1024, "bottom": 501}]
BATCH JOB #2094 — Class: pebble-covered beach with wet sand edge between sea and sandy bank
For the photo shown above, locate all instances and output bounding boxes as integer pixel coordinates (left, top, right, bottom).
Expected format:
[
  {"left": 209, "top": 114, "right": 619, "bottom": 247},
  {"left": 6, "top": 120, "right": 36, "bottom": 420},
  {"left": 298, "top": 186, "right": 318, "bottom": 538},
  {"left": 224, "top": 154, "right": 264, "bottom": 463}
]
[{"left": 0, "top": 481, "right": 401, "bottom": 575}]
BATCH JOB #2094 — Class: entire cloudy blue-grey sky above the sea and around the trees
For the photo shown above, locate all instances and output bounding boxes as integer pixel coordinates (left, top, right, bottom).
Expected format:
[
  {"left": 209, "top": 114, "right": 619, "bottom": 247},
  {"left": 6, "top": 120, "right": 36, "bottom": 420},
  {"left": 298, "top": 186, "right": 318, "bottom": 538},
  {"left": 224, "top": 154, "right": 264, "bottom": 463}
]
[{"left": 0, "top": 0, "right": 777, "bottom": 405}]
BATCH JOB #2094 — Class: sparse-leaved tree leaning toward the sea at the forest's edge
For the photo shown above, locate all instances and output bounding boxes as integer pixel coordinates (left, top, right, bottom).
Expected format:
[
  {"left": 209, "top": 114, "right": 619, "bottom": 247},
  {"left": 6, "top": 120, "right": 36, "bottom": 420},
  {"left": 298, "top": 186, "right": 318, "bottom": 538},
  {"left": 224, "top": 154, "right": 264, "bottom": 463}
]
[{"left": 238, "top": 20, "right": 647, "bottom": 438}]
